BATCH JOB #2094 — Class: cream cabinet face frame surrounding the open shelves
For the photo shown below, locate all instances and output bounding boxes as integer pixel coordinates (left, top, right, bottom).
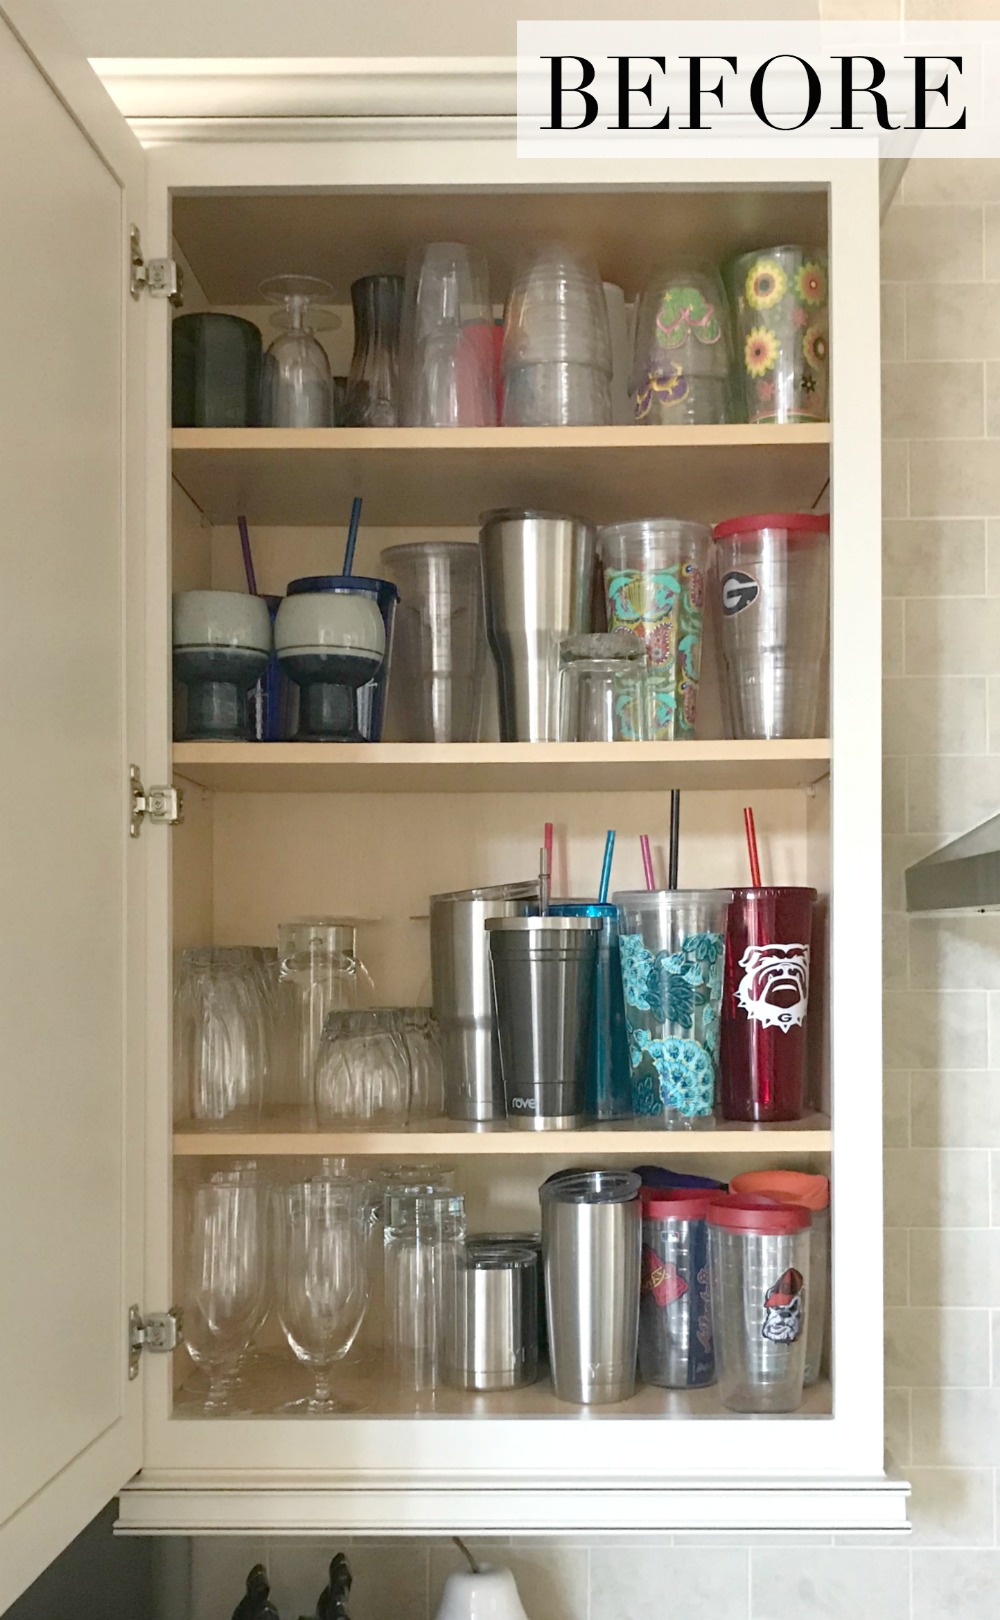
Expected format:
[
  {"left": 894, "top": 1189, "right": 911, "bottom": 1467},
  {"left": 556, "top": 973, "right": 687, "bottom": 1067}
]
[{"left": 123, "top": 132, "right": 904, "bottom": 1529}]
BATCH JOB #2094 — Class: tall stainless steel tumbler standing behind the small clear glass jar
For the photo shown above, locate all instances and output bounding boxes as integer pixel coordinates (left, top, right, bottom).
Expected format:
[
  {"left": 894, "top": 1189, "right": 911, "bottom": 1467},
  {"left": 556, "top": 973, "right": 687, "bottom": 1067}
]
[{"left": 480, "top": 510, "right": 596, "bottom": 742}]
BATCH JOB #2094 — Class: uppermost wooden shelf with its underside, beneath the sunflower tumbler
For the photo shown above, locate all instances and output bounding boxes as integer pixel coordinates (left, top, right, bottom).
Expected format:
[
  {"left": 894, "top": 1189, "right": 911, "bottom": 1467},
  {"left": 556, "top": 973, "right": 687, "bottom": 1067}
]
[{"left": 173, "top": 423, "right": 830, "bottom": 528}]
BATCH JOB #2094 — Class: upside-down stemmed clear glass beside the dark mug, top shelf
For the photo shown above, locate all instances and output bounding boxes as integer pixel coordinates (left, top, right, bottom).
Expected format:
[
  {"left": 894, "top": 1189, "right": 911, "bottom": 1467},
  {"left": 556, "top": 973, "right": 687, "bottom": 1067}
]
[{"left": 261, "top": 275, "right": 340, "bottom": 428}]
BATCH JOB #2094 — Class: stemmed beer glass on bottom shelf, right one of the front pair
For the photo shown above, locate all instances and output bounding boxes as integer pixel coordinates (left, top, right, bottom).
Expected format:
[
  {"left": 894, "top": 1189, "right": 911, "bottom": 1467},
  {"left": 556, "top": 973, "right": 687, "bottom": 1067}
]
[{"left": 272, "top": 1178, "right": 370, "bottom": 1418}]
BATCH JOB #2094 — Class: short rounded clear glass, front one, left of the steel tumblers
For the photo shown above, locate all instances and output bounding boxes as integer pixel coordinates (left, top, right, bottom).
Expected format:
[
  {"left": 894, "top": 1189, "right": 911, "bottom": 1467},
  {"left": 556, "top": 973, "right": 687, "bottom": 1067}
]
[{"left": 314, "top": 1008, "right": 410, "bottom": 1128}]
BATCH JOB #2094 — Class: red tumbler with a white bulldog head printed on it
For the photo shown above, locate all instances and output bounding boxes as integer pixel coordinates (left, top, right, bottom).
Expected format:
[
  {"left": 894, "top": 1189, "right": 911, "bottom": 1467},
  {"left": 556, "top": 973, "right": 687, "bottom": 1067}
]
[{"left": 720, "top": 886, "right": 817, "bottom": 1124}]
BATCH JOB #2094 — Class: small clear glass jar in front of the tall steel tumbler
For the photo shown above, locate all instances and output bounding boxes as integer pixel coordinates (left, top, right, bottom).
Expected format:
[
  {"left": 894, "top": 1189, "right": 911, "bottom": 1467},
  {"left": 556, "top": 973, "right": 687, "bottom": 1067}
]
[{"left": 559, "top": 632, "right": 650, "bottom": 742}]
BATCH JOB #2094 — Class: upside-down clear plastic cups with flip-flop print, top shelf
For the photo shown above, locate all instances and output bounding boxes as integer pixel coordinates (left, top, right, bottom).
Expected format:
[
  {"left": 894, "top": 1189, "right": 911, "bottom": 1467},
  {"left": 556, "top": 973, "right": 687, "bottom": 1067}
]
[{"left": 630, "top": 266, "right": 733, "bottom": 428}]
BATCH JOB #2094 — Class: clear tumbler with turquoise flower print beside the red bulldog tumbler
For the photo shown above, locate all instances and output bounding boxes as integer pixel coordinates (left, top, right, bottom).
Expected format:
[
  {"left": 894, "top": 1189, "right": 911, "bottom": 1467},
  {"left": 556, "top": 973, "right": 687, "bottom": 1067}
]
[{"left": 613, "top": 889, "right": 733, "bottom": 1131}]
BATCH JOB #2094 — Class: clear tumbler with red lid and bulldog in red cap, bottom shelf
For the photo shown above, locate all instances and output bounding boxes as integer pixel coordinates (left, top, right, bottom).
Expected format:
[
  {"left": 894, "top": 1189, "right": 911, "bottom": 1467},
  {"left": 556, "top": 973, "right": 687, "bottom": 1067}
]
[{"left": 708, "top": 1192, "right": 810, "bottom": 1413}]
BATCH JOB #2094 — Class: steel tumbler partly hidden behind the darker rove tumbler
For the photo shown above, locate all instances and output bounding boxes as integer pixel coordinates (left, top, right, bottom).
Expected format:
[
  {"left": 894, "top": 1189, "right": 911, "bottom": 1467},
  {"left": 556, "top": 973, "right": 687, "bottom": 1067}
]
[{"left": 431, "top": 881, "right": 538, "bottom": 1123}]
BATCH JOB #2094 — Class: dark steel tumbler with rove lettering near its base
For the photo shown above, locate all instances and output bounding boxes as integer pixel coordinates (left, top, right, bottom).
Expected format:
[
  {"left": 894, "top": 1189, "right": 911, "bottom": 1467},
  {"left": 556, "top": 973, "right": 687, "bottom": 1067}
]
[{"left": 486, "top": 917, "right": 603, "bottom": 1131}]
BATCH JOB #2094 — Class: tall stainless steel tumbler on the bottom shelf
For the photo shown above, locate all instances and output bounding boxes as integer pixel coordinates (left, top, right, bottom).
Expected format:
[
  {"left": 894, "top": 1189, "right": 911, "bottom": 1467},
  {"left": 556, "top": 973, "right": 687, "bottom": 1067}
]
[{"left": 538, "top": 1170, "right": 642, "bottom": 1406}]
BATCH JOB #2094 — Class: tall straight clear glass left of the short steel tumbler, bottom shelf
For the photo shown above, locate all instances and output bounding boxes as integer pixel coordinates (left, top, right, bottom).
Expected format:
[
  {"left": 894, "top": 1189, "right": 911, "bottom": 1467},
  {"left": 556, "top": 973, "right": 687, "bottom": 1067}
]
[{"left": 384, "top": 1191, "right": 465, "bottom": 1393}]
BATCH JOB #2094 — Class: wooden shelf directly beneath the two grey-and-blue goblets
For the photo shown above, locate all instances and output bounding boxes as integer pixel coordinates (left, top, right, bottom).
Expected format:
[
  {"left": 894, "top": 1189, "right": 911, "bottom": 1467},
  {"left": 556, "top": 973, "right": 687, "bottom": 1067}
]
[{"left": 173, "top": 737, "right": 830, "bottom": 794}]
